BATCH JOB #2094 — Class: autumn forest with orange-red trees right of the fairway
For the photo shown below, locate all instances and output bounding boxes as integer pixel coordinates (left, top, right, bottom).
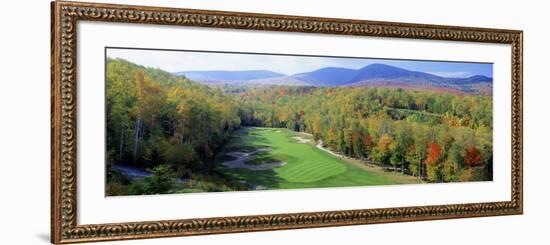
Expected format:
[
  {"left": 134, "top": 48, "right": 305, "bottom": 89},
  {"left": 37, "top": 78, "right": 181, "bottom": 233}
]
[{"left": 235, "top": 87, "right": 493, "bottom": 182}]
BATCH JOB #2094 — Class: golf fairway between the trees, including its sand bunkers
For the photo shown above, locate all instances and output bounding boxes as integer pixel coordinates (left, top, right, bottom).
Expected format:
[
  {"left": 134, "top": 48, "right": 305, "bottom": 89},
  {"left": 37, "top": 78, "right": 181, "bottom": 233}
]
[{"left": 218, "top": 127, "right": 417, "bottom": 189}]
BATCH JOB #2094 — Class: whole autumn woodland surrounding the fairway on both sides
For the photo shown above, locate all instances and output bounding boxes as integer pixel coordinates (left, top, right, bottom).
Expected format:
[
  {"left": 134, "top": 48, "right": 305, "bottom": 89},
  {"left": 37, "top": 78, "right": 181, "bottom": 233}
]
[{"left": 106, "top": 59, "right": 493, "bottom": 195}]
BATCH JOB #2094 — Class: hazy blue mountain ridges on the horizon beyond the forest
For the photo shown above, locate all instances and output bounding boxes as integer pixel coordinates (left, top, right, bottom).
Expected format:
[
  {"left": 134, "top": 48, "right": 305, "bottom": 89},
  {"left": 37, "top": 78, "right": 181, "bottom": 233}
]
[{"left": 175, "top": 64, "right": 493, "bottom": 95}]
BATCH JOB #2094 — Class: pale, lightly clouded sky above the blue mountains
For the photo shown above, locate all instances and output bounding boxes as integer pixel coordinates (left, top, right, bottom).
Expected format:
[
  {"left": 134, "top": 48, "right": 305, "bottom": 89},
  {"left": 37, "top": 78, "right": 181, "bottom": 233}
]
[{"left": 107, "top": 48, "right": 493, "bottom": 77}]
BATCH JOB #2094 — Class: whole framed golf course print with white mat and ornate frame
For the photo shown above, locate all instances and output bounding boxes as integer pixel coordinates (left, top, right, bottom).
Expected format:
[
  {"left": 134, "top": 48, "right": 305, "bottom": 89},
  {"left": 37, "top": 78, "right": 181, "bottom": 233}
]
[{"left": 51, "top": 1, "right": 523, "bottom": 244}]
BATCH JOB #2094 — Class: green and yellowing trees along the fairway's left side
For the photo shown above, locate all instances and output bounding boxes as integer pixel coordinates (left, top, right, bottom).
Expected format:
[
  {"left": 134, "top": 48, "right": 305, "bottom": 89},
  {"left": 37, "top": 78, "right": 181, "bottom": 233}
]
[{"left": 106, "top": 59, "right": 241, "bottom": 194}]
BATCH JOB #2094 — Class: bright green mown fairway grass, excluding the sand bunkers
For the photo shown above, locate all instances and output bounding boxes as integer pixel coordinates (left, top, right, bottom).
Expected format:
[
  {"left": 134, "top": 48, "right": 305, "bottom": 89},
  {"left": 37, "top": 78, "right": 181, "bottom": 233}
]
[{"left": 220, "top": 127, "right": 414, "bottom": 189}]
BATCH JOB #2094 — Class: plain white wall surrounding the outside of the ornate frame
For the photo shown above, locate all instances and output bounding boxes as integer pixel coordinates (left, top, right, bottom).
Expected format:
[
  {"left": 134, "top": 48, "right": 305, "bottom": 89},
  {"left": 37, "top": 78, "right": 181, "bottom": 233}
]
[{"left": 0, "top": 0, "right": 550, "bottom": 245}]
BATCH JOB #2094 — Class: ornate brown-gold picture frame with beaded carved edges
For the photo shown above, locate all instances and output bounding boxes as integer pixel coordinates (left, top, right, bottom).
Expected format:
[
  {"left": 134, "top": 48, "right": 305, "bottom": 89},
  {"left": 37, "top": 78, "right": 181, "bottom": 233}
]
[{"left": 51, "top": 1, "right": 523, "bottom": 244}]
